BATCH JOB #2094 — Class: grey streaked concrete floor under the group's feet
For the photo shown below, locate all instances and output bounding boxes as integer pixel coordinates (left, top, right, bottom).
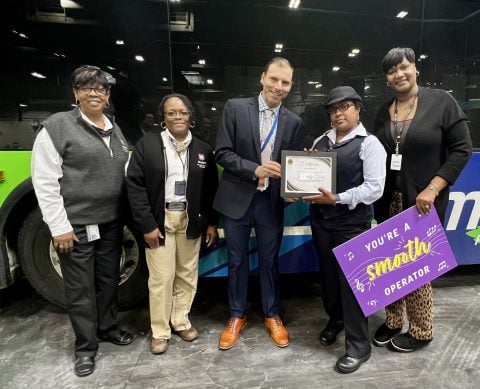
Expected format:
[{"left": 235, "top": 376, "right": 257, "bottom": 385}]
[{"left": 0, "top": 266, "right": 480, "bottom": 389}]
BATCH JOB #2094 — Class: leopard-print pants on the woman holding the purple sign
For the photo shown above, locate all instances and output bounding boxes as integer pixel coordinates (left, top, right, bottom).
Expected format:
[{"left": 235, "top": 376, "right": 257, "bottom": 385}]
[{"left": 385, "top": 192, "right": 433, "bottom": 340}]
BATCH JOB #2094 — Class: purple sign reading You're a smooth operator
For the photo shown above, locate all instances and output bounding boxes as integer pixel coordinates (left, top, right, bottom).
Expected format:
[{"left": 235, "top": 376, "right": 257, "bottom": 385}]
[{"left": 333, "top": 206, "right": 457, "bottom": 316}]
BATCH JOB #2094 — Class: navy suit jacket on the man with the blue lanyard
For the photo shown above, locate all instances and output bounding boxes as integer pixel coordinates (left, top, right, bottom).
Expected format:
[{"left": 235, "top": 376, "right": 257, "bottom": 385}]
[{"left": 213, "top": 97, "right": 302, "bottom": 223}]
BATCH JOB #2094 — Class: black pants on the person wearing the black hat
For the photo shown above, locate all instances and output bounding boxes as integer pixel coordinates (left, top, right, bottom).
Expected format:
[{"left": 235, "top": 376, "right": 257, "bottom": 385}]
[{"left": 310, "top": 206, "right": 371, "bottom": 358}]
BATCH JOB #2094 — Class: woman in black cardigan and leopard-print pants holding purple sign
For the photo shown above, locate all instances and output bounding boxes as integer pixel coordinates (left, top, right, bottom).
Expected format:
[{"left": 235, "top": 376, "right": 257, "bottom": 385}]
[{"left": 373, "top": 48, "right": 472, "bottom": 352}]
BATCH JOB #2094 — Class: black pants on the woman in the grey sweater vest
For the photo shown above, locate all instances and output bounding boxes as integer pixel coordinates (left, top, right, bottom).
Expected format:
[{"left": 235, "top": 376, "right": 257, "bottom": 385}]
[{"left": 60, "top": 221, "right": 123, "bottom": 357}]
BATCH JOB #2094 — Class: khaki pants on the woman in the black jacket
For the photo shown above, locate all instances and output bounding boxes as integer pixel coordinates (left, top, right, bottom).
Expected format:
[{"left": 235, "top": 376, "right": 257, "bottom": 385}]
[{"left": 146, "top": 210, "right": 201, "bottom": 339}]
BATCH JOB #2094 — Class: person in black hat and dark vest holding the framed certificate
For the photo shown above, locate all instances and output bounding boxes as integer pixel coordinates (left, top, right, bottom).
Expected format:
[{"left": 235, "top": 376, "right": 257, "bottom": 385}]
[{"left": 303, "top": 86, "right": 386, "bottom": 373}]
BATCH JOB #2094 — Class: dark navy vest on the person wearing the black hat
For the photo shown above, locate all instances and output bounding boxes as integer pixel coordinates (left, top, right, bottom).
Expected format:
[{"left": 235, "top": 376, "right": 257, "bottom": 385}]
[{"left": 312, "top": 136, "right": 372, "bottom": 223}]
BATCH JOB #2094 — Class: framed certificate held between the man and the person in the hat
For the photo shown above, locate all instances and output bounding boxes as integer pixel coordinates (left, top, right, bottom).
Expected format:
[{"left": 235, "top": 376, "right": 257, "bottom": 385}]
[{"left": 280, "top": 150, "right": 337, "bottom": 197}]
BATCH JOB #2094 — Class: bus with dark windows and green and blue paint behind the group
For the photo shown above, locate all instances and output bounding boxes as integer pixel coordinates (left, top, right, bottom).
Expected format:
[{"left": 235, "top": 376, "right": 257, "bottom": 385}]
[{"left": 0, "top": 0, "right": 480, "bottom": 308}]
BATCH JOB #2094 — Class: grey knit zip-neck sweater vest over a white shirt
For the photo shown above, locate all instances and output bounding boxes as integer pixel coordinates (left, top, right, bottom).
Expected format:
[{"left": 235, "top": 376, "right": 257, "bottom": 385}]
[{"left": 42, "top": 108, "right": 128, "bottom": 225}]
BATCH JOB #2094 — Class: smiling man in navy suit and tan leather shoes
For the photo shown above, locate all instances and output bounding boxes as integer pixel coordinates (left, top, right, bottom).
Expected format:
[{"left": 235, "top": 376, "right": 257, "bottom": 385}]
[{"left": 213, "top": 57, "right": 301, "bottom": 350}]
